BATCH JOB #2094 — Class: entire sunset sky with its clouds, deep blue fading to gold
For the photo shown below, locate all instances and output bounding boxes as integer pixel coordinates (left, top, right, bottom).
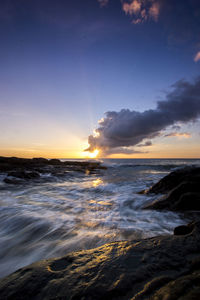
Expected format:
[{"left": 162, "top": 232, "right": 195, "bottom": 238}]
[{"left": 0, "top": 0, "right": 200, "bottom": 158}]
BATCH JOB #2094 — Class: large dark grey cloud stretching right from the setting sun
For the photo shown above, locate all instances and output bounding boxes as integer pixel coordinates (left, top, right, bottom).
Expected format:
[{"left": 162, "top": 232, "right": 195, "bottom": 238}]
[{"left": 87, "top": 77, "right": 200, "bottom": 154}]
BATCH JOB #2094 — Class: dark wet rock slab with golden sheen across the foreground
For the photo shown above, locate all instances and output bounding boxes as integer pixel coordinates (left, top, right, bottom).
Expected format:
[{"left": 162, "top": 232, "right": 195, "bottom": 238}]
[{"left": 0, "top": 222, "right": 200, "bottom": 300}]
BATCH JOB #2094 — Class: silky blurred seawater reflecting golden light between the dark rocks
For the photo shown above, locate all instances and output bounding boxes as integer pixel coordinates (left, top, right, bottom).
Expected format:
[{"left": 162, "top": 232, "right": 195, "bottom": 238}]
[{"left": 0, "top": 159, "right": 200, "bottom": 277}]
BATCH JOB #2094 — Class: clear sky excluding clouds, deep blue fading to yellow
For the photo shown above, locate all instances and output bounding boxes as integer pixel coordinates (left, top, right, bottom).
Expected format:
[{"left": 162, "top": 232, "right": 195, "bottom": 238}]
[{"left": 0, "top": 0, "right": 200, "bottom": 157}]
